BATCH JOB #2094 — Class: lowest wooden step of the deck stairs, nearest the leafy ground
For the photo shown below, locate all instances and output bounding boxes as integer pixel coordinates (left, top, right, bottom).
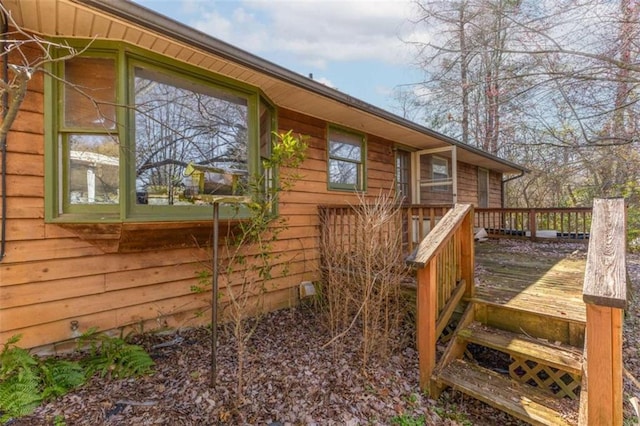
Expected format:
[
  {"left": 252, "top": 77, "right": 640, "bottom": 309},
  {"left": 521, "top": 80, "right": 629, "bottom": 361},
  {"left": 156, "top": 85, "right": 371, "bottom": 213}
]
[{"left": 434, "top": 359, "right": 577, "bottom": 426}]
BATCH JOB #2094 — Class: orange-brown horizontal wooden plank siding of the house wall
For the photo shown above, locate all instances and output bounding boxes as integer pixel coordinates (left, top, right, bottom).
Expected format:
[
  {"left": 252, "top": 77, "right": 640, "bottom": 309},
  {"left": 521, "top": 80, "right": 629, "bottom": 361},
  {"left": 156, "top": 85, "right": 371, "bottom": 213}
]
[{"left": 0, "top": 18, "right": 516, "bottom": 350}]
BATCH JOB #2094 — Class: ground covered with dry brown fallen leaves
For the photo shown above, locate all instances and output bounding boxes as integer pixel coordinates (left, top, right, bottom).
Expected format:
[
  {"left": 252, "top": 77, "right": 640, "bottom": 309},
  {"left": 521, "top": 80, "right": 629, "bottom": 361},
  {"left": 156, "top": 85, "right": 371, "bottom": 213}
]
[{"left": 12, "top": 242, "right": 640, "bottom": 426}]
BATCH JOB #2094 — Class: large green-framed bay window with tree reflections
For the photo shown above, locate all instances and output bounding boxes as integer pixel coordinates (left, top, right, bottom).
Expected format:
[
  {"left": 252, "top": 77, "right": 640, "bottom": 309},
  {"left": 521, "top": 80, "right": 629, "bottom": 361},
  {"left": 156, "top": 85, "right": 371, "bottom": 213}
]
[{"left": 47, "top": 42, "right": 275, "bottom": 221}]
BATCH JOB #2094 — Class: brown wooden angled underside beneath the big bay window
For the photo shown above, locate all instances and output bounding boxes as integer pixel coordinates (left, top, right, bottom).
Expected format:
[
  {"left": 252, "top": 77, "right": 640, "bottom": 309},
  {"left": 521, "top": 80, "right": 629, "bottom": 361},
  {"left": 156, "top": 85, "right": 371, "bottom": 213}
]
[{"left": 54, "top": 218, "right": 246, "bottom": 253}]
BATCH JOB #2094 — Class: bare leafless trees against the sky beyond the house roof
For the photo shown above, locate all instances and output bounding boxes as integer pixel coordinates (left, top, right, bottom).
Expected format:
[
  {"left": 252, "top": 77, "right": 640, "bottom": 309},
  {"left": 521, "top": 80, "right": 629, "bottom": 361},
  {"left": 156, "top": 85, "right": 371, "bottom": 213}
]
[{"left": 408, "top": 0, "right": 640, "bottom": 205}]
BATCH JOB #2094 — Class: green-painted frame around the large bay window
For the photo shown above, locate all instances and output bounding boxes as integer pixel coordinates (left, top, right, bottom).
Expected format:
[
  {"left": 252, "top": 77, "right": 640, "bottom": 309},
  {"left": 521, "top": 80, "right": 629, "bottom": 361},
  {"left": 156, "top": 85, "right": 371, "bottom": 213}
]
[{"left": 44, "top": 40, "right": 277, "bottom": 223}]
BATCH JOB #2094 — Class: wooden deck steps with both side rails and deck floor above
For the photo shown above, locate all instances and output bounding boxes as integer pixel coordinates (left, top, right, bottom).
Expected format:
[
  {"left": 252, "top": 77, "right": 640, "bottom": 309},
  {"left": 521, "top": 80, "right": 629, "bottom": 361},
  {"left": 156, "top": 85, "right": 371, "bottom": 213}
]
[{"left": 407, "top": 199, "right": 628, "bottom": 426}]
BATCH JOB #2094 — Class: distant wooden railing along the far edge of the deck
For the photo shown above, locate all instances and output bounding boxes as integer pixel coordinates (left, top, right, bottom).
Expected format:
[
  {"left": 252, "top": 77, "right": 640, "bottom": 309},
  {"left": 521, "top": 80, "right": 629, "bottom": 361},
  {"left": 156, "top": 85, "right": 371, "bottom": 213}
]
[{"left": 474, "top": 207, "right": 592, "bottom": 241}]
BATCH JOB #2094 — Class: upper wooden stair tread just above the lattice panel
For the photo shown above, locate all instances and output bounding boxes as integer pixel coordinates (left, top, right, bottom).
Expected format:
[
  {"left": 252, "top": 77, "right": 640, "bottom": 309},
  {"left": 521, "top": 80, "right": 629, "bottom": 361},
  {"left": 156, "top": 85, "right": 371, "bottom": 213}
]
[{"left": 458, "top": 322, "right": 583, "bottom": 376}]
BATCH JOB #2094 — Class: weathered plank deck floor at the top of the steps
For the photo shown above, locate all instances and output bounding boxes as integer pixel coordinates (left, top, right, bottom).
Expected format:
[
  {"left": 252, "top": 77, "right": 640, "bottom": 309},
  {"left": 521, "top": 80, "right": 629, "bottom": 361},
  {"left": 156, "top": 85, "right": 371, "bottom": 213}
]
[{"left": 473, "top": 240, "right": 586, "bottom": 346}]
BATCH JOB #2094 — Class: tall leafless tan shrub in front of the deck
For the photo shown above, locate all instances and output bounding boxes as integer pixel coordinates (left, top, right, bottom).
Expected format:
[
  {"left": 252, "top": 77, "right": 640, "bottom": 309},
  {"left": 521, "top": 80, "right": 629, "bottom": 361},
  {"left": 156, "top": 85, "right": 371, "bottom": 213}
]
[{"left": 321, "top": 193, "right": 407, "bottom": 367}]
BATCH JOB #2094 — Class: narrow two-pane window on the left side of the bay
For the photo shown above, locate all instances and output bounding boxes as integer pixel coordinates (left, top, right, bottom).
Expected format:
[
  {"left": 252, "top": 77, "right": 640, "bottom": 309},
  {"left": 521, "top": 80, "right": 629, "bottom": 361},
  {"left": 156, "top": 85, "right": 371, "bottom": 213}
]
[{"left": 58, "top": 56, "right": 121, "bottom": 213}]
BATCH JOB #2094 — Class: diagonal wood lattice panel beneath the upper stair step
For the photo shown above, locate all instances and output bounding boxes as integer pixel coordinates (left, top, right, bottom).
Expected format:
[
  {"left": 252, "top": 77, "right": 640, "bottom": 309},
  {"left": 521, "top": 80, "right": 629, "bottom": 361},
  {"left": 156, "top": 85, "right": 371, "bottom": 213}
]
[{"left": 509, "top": 356, "right": 581, "bottom": 399}]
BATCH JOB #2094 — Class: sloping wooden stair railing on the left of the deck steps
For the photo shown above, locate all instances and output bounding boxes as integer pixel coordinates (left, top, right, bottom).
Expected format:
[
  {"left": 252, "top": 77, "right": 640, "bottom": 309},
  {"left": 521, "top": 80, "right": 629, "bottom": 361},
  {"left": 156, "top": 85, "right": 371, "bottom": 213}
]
[{"left": 407, "top": 204, "right": 474, "bottom": 389}]
